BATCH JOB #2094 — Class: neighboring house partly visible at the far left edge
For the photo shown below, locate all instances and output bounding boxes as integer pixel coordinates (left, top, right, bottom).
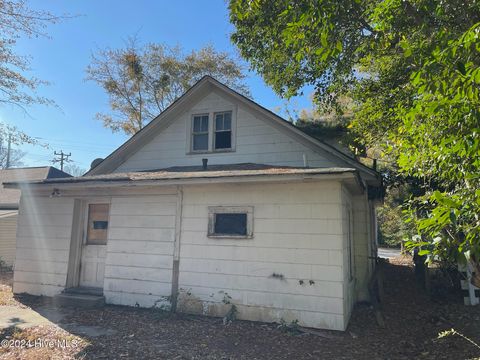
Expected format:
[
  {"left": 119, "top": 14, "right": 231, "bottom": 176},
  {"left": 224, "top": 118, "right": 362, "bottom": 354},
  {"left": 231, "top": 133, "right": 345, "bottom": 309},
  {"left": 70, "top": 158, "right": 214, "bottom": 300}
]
[{"left": 0, "top": 166, "right": 70, "bottom": 267}]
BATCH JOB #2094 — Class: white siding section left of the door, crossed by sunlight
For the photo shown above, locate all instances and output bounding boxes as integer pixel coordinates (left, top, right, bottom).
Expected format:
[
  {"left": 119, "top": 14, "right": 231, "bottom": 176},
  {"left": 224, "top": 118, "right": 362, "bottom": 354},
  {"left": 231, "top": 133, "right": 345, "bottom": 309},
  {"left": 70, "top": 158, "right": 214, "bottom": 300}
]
[{"left": 13, "top": 194, "right": 73, "bottom": 296}]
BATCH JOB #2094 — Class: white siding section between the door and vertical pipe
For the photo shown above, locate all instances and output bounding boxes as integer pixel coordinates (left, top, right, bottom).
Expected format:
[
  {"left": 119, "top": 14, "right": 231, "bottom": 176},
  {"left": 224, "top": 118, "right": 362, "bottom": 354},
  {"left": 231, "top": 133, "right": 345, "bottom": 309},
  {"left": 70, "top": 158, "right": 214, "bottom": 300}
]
[{"left": 104, "top": 190, "right": 177, "bottom": 307}]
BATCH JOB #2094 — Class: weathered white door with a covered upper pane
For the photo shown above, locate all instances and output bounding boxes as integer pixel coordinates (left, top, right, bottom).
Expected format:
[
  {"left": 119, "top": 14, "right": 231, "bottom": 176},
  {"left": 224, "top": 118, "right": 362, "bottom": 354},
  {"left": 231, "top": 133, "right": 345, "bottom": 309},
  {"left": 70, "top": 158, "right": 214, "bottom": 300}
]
[{"left": 79, "top": 203, "right": 110, "bottom": 288}]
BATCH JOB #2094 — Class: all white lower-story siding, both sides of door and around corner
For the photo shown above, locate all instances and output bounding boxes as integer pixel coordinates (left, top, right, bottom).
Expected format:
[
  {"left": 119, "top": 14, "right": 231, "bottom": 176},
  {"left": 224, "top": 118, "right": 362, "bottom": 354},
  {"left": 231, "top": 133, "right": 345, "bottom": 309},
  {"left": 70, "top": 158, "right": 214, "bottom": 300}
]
[{"left": 14, "top": 181, "right": 370, "bottom": 330}]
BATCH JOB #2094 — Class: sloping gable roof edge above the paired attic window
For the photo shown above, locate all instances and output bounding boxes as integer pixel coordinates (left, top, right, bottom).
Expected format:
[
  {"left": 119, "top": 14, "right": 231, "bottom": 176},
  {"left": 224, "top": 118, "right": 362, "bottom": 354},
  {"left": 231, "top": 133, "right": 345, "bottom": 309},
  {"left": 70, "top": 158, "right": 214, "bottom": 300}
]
[{"left": 85, "top": 75, "right": 380, "bottom": 182}]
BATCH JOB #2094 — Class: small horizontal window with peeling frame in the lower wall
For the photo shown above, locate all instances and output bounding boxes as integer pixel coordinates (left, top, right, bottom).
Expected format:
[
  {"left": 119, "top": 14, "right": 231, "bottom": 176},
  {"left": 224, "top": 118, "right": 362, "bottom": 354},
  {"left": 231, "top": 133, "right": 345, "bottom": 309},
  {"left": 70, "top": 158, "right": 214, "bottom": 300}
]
[{"left": 208, "top": 206, "right": 253, "bottom": 238}]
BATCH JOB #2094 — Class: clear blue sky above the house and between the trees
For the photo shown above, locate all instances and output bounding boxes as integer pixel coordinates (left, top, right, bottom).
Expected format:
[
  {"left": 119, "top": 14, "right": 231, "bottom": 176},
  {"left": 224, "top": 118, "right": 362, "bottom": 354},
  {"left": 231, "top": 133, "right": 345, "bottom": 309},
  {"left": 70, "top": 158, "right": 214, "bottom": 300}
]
[{"left": 0, "top": 0, "right": 310, "bottom": 169}]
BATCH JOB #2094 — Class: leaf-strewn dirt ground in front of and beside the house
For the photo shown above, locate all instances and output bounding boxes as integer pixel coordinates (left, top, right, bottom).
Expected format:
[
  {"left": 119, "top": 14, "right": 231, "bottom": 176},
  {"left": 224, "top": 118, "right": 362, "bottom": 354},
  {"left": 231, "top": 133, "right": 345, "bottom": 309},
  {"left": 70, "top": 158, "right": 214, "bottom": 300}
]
[{"left": 0, "top": 258, "right": 480, "bottom": 359}]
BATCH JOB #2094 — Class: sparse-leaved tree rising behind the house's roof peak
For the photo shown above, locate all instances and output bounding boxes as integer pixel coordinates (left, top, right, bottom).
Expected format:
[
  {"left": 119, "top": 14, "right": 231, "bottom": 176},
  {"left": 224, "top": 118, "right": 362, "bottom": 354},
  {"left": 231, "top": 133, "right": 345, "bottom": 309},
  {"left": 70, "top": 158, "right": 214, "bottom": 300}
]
[{"left": 86, "top": 39, "right": 248, "bottom": 135}]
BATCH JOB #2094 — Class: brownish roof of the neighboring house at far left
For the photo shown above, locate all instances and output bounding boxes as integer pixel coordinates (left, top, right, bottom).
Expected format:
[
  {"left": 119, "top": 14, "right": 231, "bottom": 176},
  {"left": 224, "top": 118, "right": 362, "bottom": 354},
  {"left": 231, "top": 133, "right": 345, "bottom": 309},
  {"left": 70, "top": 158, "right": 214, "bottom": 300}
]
[{"left": 0, "top": 166, "right": 71, "bottom": 210}]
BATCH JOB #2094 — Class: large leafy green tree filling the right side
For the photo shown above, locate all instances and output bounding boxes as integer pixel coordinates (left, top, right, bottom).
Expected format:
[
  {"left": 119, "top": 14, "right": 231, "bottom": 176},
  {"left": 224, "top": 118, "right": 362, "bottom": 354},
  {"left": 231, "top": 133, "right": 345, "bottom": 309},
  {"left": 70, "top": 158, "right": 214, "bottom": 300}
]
[{"left": 230, "top": 0, "right": 480, "bottom": 284}]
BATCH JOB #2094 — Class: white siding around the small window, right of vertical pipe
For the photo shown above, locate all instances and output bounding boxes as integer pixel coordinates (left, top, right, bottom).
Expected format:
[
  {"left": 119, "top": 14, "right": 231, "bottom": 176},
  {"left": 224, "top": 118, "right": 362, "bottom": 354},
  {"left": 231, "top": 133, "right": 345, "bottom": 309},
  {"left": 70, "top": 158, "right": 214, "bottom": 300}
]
[{"left": 179, "top": 182, "right": 346, "bottom": 330}]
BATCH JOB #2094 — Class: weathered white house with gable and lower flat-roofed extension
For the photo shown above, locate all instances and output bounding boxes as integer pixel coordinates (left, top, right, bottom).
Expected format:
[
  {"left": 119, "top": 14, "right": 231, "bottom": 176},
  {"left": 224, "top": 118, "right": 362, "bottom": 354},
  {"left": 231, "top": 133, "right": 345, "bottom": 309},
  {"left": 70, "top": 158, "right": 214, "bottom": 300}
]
[{"left": 7, "top": 76, "right": 381, "bottom": 330}]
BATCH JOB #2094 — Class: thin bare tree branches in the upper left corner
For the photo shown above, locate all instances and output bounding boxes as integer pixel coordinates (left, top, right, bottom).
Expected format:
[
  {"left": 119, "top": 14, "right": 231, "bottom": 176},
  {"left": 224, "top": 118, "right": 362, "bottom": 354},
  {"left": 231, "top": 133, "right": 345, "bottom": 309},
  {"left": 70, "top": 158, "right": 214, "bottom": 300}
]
[{"left": 0, "top": 0, "right": 67, "bottom": 108}]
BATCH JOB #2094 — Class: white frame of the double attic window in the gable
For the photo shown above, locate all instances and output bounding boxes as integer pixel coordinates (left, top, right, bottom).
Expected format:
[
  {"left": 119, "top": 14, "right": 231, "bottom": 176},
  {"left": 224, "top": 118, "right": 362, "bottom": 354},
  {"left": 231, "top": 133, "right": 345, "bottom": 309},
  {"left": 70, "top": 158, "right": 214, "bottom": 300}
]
[{"left": 185, "top": 106, "right": 237, "bottom": 155}]
